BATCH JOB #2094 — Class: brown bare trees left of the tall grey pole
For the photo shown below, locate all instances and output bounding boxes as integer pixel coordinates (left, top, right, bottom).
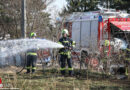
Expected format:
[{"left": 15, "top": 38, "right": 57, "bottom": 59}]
[{"left": 0, "top": 0, "right": 21, "bottom": 39}]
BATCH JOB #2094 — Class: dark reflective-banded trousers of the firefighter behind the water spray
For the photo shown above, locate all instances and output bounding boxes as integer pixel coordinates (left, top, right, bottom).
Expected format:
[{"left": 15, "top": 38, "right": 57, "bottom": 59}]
[{"left": 26, "top": 55, "right": 37, "bottom": 73}]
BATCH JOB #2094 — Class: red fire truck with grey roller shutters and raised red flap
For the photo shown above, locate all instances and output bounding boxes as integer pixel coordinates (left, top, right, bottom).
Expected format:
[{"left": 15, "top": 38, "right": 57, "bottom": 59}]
[{"left": 64, "top": 12, "right": 130, "bottom": 67}]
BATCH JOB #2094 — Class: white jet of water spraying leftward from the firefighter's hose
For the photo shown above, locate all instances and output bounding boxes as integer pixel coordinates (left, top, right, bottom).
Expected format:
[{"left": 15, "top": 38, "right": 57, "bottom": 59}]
[{"left": 0, "top": 39, "right": 64, "bottom": 72}]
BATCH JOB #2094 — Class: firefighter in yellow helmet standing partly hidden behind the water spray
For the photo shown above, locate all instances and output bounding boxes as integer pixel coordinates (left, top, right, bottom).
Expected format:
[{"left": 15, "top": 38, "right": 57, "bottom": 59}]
[{"left": 26, "top": 32, "right": 37, "bottom": 74}]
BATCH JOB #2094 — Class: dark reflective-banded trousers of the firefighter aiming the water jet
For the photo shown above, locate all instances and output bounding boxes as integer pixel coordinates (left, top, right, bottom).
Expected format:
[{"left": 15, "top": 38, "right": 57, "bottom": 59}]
[{"left": 60, "top": 55, "right": 73, "bottom": 75}]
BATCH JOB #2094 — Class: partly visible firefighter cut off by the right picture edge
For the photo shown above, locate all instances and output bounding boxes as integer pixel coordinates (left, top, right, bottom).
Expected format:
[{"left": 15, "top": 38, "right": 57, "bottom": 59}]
[{"left": 125, "top": 45, "right": 130, "bottom": 76}]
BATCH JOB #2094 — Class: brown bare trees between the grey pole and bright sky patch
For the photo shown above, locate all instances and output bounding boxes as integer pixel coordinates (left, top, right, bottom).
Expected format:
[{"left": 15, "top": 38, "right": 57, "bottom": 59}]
[{"left": 27, "top": 0, "right": 54, "bottom": 38}]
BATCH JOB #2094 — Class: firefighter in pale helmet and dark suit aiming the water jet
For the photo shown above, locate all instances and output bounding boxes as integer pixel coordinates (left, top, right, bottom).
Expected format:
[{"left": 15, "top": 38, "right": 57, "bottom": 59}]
[{"left": 59, "top": 29, "right": 75, "bottom": 76}]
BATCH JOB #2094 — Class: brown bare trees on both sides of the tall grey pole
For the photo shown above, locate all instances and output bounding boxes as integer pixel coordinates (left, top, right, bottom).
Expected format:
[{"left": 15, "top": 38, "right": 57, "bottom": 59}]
[{"left": 0, "top": 0, "right": 54, "bottom": 39}]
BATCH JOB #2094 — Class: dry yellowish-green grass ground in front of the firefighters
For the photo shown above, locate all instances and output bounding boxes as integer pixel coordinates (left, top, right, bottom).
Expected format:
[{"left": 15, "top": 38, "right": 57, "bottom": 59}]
[{"left": 1, "top": 69, "right": 130, "bottom": 90}]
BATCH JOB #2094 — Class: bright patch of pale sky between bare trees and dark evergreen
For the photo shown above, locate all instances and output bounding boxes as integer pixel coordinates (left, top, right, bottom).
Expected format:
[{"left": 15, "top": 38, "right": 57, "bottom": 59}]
[{"left": 46, "top": 0, "right": 67, "bottom": 23}]
